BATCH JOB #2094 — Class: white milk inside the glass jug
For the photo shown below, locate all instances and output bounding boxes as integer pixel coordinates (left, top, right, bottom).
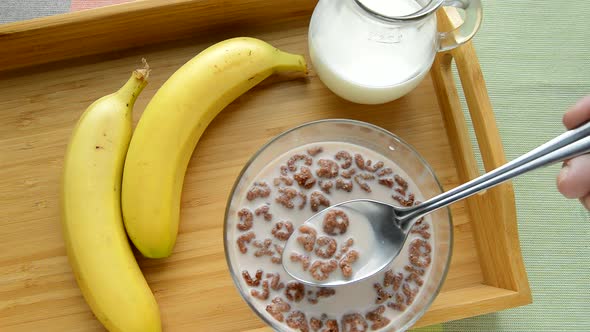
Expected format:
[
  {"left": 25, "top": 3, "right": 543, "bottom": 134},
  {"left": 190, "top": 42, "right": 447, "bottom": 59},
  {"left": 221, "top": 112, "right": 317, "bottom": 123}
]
[{"left": 309, "top": 0, "right": 436, "bottom": 104}]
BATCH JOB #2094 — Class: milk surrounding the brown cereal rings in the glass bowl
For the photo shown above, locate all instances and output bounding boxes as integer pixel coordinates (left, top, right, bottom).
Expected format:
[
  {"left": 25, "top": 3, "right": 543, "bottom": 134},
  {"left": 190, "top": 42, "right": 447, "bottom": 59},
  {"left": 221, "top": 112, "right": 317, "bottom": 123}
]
[{"left": 226, "top": 142, "right": 435, "bottom": 331}]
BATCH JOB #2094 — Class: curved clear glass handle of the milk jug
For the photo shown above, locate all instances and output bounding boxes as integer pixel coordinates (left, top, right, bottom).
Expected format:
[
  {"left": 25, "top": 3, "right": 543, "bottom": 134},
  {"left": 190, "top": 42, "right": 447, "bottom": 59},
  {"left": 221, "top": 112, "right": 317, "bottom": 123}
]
[{"left": 438, "top": 0, "right": 483, "bottom": 52}]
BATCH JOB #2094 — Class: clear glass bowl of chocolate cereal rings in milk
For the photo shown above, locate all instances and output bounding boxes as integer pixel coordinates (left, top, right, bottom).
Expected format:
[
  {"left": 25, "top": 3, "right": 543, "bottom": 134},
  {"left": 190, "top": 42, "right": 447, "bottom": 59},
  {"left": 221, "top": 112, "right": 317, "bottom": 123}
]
[{"left": 224, "top": 119, "right": 452, "bottom": 332}]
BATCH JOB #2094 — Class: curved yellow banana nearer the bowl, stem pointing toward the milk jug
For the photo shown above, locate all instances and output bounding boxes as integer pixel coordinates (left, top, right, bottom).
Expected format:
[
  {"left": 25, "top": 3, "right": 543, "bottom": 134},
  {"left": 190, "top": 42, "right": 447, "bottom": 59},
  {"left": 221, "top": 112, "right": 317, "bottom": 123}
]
[{"left": 122, "top": 38, "right": 307, "bottom": 258}]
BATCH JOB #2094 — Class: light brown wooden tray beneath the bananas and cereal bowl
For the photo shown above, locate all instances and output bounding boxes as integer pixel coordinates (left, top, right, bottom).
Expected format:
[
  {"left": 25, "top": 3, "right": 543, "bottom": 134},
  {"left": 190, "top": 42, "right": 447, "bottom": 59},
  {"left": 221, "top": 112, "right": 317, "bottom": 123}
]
[{"left": 0, "top": 0, "right": 531, "bottom": 332}]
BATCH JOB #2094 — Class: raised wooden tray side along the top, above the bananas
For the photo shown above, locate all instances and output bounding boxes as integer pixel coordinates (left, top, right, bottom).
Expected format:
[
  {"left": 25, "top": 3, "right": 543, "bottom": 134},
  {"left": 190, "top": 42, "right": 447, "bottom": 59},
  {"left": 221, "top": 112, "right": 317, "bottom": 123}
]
[{"left": 0, "top": 0, "right": 317, "bottom": 71}]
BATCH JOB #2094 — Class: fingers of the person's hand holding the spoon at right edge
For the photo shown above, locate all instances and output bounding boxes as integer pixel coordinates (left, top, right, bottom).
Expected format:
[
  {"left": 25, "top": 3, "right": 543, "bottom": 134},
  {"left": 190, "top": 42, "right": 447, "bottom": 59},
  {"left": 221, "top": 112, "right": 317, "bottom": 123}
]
[{"left": 557, "top": 96, "right": 590, "bottom": 210}]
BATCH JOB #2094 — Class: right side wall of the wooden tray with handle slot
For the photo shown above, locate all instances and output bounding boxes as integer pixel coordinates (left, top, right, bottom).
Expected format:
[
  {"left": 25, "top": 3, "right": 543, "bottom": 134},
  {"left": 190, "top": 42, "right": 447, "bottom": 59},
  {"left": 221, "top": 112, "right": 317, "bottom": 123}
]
[{"left": 431, "top": 8, "right": 530, "bottom": 302}]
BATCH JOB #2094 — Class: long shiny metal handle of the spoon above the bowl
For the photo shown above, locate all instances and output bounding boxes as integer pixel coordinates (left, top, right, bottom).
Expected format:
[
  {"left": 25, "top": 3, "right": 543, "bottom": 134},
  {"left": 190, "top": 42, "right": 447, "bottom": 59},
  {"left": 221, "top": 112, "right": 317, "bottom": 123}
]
[{"left": 397, "top": 122, "right": 590, "bottom": 228}]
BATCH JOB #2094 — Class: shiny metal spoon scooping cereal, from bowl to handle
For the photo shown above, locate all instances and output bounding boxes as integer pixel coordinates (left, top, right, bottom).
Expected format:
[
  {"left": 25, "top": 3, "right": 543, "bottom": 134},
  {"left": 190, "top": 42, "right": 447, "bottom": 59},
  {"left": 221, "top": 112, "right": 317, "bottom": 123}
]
[{"left": 282, "top": 122, "right": 590, "bottom": 287}]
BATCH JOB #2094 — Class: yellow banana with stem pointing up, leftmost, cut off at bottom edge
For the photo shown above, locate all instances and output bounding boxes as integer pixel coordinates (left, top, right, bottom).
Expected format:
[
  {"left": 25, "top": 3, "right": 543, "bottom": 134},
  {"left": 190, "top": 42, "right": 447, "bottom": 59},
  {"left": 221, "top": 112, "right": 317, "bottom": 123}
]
[{"left": 61, "top": 65, "right": 161, "bottom": 332}]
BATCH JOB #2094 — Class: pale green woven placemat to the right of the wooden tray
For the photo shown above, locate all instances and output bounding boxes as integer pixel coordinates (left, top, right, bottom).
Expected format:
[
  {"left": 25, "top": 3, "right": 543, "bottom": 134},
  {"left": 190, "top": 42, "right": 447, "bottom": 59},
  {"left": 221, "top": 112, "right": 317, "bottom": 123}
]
[{"left": 434, "top": 0, "right": 590, "bottom": 332}]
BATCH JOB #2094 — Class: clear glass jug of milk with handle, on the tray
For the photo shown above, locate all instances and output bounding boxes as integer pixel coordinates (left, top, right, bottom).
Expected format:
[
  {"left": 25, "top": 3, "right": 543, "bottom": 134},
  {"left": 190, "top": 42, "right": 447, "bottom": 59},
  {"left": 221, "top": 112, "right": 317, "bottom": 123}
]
[{"left": 308, "top": 0, "right": 482, "bottom": 104}]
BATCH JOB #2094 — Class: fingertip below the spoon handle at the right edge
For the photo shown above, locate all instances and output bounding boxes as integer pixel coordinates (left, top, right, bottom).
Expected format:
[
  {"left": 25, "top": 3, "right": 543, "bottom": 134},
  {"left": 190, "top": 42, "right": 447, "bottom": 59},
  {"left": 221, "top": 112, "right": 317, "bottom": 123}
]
[{"left": 557, "top": 154, "right": 590, "bottom": 198}]
